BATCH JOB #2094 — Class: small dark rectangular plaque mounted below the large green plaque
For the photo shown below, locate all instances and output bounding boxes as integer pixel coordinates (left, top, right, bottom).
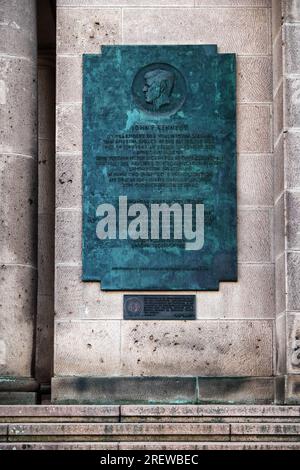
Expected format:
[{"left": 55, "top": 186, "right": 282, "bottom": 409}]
[{"left": 124, "top": 295, "right": 196, "bottom": 320}]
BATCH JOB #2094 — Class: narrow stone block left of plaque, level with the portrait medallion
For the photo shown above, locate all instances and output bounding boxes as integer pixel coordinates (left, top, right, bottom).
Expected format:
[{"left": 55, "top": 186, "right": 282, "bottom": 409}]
[{"left": 56, "top": 55, "right": 82, "bottom": 104}]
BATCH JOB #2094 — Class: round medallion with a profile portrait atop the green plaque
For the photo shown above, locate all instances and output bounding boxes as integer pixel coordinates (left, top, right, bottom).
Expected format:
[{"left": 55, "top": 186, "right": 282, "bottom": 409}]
[{"left": 132, "top": 63, "right": 186, "bottom": 117}]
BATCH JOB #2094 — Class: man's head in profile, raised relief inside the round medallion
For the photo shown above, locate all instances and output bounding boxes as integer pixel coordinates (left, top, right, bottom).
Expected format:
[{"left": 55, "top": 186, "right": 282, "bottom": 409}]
[{"left": 143, "top": 69, "right": 175, "bottom": 111}]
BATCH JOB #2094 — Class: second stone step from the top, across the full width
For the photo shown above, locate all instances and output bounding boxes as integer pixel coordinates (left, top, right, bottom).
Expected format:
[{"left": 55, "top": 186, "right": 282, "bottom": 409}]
[{"left": 0, "top": 423, "right": 300, "bottom": 442}]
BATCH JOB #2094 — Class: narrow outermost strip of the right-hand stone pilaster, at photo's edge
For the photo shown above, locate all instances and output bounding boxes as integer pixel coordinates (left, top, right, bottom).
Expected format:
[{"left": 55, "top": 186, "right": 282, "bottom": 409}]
[{"left": 282, "top": 0, "right": 300, "bottom": 403}]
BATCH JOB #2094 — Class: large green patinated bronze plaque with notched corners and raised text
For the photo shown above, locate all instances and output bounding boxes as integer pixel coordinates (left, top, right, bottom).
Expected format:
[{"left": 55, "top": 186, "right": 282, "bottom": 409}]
[{"left": 82, "top": 45, "right": 237, "bottom": 290}]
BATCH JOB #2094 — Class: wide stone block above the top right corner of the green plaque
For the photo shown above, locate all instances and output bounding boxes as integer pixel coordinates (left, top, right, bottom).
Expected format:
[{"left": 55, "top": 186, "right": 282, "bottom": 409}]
[{"left": 123, "top": 8, "right": 270, "bottom": 55}]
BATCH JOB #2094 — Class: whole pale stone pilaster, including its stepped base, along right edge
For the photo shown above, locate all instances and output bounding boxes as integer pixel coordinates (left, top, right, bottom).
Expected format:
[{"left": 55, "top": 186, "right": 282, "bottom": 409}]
[{"left": 272, "top": 0, "right": 300, "bottom": 403}]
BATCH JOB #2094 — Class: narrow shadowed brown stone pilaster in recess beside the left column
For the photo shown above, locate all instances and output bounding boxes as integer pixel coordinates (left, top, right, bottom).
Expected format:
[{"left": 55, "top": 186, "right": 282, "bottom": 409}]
[{"left": 35, "top": 50, "right": 55, "bottom": 384}]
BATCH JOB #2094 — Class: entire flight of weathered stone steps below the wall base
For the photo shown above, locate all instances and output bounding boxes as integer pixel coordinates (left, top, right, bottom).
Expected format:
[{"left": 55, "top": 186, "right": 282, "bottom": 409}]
[{"left": 0, "top": 405, "right": 300, "bottom": 450}]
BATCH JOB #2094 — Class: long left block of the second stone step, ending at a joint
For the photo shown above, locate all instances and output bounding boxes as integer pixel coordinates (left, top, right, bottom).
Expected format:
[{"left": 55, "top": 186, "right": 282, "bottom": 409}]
[{"left": 7, "top": 423, "right": 230, "bottom": 441}]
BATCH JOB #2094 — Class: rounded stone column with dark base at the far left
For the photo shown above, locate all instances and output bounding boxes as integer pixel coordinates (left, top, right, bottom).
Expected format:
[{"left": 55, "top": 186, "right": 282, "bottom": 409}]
[{"left": 0, "top": 0, "right": 37, "bottom": 403}]
